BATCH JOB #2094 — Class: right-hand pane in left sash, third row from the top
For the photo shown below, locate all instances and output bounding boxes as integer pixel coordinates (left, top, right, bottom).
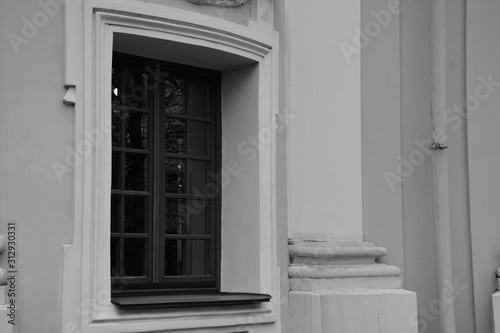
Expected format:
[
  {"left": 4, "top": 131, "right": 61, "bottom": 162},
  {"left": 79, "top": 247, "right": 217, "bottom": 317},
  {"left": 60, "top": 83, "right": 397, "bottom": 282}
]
[{"left": 125, "top": 154, "right": 149, "bottom": 191}]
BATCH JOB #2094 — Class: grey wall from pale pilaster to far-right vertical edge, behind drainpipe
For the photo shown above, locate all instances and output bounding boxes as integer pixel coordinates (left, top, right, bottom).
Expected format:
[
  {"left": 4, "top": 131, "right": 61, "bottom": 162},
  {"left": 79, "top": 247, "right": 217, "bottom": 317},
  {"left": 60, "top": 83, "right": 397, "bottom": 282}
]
[{"left": 362, "top": 0, "right": 474, "bottom": 333}]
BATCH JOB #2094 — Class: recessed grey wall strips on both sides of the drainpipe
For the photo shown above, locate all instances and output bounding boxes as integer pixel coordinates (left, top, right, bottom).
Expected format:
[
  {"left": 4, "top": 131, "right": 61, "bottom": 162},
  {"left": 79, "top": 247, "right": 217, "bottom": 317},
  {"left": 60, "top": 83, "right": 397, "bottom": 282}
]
[{"left": 401, "top": 0, "right": 476, "bottom": 333}]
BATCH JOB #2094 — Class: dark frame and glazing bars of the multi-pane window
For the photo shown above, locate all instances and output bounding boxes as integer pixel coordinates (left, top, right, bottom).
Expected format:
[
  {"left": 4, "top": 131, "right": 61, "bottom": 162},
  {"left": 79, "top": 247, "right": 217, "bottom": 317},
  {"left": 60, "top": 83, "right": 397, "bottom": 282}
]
[{"left": 111, "top": 52, "right": 222, "bottom": 300}]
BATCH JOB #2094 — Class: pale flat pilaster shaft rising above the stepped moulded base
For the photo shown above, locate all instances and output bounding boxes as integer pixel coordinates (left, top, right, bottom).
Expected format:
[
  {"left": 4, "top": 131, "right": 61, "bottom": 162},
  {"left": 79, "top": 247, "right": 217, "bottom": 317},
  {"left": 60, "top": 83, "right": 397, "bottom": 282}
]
[{"left": 284, "top": 0, "right": 362, "bottom": 240}]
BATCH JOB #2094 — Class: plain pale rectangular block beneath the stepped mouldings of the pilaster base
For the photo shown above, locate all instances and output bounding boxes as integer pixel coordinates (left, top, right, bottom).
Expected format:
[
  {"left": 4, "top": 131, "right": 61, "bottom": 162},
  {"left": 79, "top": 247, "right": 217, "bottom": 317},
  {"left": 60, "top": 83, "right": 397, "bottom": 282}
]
[{"left": 289, "top": 289, "right": 418, "bottom": 333}]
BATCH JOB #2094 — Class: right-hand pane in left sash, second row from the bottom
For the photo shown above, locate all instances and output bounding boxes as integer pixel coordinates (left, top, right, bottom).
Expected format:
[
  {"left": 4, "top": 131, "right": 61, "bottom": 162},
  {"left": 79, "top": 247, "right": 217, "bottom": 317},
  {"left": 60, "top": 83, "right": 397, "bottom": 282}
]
[{"left": 124, "top": 195, "right": 149, "bottom": 233}]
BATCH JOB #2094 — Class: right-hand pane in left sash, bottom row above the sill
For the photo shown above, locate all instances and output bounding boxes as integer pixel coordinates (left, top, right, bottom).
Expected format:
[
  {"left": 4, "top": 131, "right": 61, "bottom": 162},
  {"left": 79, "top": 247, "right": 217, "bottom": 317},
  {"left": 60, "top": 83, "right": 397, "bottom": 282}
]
[{"left": 123, "top": 238, "right": 148, "bottom": 276}]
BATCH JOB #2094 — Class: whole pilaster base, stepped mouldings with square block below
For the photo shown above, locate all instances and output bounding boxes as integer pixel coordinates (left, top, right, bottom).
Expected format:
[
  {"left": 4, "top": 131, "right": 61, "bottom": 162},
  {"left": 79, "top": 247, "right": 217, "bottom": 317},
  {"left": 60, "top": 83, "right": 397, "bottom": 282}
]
[{"left": 288, "top": 241, "right": 418, "bottom": 333}]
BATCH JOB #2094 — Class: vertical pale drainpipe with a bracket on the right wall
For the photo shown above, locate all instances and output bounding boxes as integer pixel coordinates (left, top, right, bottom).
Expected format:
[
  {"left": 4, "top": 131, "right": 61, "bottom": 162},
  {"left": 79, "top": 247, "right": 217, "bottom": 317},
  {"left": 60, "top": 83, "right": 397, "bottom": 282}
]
[{"left": 430, "top": 0, "right": 456, "bottom": 333}]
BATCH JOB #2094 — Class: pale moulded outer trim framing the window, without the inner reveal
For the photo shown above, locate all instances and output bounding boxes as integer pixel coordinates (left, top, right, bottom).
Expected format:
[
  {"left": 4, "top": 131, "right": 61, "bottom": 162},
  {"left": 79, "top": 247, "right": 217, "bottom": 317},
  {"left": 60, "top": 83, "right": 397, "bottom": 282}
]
[{"left": 59, "top": 0, "right": 280, "bottom": 332}]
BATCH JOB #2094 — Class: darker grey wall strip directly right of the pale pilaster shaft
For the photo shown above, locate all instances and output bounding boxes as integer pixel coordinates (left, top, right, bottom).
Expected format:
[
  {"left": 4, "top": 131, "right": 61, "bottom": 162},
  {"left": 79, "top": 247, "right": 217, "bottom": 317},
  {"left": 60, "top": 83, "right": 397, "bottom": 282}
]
[{"left": 361, "top": 0, "right": 404, "bottom": 275}]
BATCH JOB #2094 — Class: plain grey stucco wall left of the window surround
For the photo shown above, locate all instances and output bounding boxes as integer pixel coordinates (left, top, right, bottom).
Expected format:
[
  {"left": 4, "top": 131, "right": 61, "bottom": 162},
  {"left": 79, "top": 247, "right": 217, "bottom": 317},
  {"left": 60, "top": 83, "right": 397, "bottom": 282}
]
[{"left": 0, "top": 0, "right": 74, "bottom": 333}]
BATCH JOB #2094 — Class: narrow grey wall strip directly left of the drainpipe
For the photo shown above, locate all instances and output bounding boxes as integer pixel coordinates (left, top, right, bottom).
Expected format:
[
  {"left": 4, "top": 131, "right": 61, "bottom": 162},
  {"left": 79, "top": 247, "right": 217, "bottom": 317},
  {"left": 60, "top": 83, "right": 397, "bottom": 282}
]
[{"left": 401, "top": 8, "right": 439, "bottom": 333}]
